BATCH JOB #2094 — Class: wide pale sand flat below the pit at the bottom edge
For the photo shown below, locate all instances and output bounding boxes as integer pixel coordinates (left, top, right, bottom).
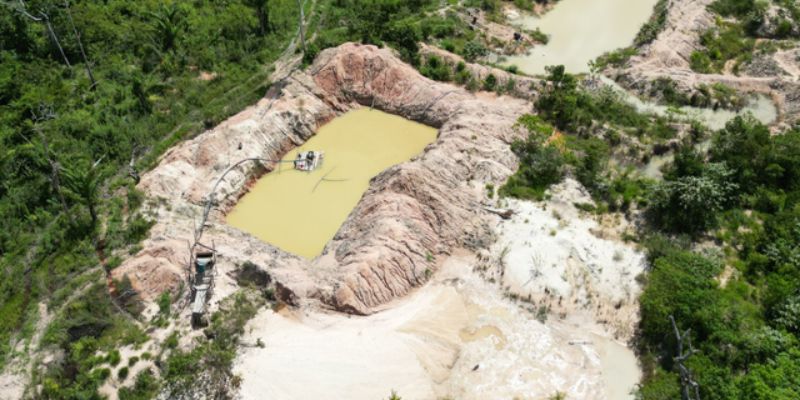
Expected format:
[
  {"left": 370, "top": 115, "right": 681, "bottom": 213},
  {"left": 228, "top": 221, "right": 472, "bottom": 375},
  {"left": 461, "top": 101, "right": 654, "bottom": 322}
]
[{"left": 234, "top": 255, "right": 638, "bottom": 400}]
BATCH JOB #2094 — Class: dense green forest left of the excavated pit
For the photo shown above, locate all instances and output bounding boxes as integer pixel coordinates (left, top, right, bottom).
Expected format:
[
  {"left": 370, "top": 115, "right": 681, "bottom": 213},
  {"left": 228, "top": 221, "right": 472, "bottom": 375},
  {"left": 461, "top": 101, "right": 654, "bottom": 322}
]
[{"left": 0, "top": 0, "right": 315, "bottom": 398}]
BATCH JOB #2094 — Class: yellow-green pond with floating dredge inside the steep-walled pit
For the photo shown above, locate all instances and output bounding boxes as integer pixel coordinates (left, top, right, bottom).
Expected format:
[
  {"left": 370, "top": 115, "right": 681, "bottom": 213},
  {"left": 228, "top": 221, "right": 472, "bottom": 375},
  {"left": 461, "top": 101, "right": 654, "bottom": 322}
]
[{"left": 227, "top": 108, "right": 436, "bottom": 258}]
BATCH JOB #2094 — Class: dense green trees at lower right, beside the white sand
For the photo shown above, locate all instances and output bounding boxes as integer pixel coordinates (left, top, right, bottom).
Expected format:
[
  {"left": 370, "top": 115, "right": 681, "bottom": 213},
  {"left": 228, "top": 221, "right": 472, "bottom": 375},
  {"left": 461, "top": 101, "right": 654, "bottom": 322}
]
[{"left": 641, "top": 117, "right": 800, "bottom": 399}]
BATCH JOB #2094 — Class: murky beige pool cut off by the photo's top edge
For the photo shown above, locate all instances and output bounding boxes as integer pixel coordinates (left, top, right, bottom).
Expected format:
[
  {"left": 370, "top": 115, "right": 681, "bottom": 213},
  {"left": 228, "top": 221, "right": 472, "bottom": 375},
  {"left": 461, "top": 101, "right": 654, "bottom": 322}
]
[{"left": 504, "top": 0, "right": 657, "bottom": 75}]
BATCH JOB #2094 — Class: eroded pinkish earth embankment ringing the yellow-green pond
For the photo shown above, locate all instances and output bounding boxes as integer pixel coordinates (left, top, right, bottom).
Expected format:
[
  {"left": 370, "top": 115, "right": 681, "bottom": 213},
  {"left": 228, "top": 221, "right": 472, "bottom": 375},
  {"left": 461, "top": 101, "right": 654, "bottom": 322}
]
[{"left": 114, "top": 44, "right": 531, "bottom": 314}]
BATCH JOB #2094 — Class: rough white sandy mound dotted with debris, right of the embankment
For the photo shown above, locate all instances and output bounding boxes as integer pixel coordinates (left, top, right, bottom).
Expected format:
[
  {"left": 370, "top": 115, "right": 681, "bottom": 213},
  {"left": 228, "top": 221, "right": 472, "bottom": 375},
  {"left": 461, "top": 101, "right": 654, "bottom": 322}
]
[{"left": 490, "top": 179, "right": 645, "bottom": 340}]
